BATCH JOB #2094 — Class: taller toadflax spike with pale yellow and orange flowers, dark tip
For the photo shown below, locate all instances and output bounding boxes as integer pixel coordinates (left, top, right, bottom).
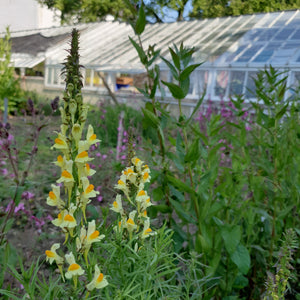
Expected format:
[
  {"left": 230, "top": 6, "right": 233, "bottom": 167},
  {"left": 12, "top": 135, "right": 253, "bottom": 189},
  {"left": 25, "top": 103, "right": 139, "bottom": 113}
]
[{"left": 45, "top": 29, "right": 108, "bottom": 298}]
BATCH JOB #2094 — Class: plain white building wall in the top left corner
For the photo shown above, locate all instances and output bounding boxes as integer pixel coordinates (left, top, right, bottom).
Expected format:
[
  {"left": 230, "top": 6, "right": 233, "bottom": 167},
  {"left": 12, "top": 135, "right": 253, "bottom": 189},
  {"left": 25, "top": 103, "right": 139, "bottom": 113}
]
[{"left": 0, "top": 0, "right": 59, "bottom": 32}]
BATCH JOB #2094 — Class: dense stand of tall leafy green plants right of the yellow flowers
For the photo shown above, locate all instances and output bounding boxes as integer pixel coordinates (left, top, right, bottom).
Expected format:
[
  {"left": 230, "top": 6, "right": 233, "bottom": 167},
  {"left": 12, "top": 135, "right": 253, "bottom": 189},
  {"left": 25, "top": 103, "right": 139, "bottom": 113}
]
[{"left": 130, "top": 3, "right": 300, "bottom": 299}]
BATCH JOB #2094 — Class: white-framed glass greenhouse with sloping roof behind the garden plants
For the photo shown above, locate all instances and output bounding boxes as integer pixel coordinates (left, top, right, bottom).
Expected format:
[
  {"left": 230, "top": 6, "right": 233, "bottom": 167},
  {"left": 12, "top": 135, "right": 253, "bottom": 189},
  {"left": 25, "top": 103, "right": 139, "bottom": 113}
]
[{"left": 5, "top": 10, "right": 300, "bottom": 104}]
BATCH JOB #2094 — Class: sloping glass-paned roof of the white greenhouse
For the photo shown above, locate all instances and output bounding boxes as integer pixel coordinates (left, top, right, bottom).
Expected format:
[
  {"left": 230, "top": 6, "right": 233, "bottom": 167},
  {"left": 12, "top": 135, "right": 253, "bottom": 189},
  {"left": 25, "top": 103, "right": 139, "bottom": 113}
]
[{"left": 3, "top": 10, "right": 300, "bottom": 72}]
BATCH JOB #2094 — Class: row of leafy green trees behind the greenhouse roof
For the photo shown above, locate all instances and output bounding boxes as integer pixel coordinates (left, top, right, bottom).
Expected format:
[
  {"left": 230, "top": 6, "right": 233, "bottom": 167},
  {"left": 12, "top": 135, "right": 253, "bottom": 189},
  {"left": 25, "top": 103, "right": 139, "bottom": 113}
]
[{"left": 37, "top": 0, "right": 300, "bottom": 23}]
